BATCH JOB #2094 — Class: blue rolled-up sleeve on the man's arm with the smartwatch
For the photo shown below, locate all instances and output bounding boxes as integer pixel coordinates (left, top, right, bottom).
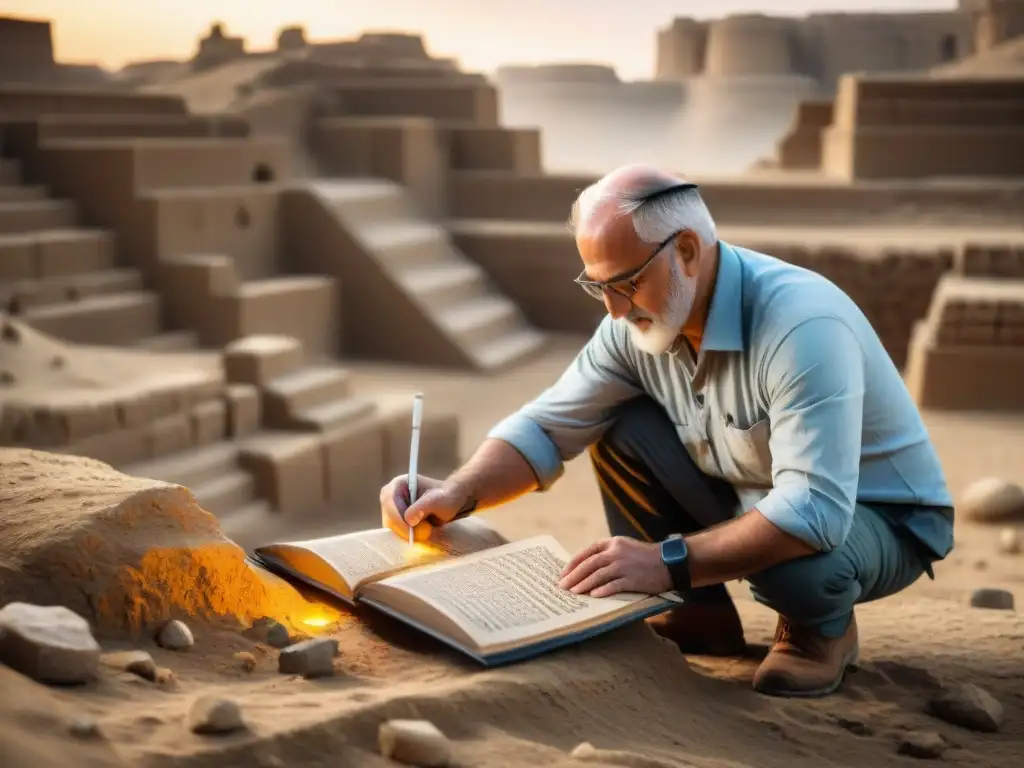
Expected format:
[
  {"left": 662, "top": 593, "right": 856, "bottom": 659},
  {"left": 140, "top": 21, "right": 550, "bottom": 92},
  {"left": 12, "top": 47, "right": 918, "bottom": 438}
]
[{"left": 757, "top": 317, "right": 864, "bottom": 552}]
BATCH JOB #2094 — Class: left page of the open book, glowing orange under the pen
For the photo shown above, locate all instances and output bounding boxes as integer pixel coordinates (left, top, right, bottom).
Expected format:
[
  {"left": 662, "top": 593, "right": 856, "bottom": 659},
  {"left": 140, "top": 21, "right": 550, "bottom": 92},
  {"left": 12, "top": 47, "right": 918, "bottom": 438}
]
[{"left": 261, "top": 517, "right": 505, "bottom": 593}]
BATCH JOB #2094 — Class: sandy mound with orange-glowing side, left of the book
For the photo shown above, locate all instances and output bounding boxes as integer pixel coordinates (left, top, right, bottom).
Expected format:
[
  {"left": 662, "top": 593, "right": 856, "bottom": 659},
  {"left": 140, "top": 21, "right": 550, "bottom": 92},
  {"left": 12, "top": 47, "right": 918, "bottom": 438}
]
[{"left": 0, "top": 449, "right": 323, "bottom": 636}]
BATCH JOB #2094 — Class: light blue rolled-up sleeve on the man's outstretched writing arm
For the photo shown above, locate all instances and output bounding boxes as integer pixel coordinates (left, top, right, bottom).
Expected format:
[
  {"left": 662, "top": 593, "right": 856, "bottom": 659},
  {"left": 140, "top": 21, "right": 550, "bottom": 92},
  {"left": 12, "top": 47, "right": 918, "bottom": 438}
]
[{"left": 487, "top": 316, "right": 641, "bottom": 490}]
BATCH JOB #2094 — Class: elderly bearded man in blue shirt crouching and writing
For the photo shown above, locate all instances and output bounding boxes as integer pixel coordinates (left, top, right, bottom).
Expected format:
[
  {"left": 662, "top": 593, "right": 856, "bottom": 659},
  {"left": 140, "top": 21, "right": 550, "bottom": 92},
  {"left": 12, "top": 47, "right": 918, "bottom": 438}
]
[{"left": 381, "top": 166, "right": 953, "bottom": 696}]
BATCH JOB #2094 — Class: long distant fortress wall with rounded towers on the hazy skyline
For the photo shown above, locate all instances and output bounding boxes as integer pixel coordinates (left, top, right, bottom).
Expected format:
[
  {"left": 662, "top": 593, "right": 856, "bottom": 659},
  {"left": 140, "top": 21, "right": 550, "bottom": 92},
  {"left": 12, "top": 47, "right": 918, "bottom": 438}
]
[{"left": 656, "top": 10, "right": 970, "bottom": 92}]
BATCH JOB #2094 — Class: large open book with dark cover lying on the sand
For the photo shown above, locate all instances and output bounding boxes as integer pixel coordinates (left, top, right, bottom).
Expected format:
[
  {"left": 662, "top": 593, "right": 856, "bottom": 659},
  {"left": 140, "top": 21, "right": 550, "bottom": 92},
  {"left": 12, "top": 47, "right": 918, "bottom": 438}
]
[{"left": 247, "top": 517, "right": 678, "bottom": 667}]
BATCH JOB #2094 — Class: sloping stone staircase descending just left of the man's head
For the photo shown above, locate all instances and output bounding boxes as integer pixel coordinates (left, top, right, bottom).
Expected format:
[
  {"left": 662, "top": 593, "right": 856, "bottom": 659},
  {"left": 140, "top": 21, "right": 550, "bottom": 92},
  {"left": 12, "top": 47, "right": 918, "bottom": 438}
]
[{"left": 290, "top": 179, "right": 545, "bottom": 371}]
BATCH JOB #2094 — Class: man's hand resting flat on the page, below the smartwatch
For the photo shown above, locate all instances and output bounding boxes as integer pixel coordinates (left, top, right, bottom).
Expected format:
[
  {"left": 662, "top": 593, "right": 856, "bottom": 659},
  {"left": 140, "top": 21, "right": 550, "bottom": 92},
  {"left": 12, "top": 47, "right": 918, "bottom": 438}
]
[{"left": 558, "top": 536, "right": 672, "bottom": 597}]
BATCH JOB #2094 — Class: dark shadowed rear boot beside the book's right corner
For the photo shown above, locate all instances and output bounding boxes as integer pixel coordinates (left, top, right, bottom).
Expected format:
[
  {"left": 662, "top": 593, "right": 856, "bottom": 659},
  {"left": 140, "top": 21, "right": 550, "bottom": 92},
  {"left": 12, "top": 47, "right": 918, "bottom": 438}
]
[{"left": 647, "top": 600, "right": 746, "bottom": 656}]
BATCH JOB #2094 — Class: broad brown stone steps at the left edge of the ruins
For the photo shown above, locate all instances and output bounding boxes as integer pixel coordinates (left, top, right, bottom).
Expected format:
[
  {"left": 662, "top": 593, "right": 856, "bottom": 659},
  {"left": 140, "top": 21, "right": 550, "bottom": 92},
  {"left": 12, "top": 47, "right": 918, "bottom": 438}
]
[{"left": 0, "top": 160, "right": 181, "bottom": 348}]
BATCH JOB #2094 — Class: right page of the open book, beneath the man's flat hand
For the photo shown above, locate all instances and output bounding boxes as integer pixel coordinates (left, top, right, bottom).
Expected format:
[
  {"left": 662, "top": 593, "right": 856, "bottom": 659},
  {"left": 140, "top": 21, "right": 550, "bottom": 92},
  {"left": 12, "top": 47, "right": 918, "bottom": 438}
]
[{"left": 375, "top": 536, "right": 649, "bottom": 647}]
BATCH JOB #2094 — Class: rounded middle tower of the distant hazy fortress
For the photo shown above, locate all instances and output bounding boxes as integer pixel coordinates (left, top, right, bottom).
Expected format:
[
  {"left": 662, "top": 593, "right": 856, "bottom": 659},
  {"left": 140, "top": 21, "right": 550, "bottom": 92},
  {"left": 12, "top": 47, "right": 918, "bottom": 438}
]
[{"left": 702, "top": 15, "right": 801, "bottom": 77}]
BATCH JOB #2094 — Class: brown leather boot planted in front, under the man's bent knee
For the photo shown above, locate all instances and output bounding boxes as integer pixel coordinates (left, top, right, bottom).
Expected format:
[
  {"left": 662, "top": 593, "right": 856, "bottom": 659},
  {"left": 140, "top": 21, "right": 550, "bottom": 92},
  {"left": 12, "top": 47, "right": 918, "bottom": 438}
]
[{"left": 754, "top": 614, "right": 859, "bottom": 697}]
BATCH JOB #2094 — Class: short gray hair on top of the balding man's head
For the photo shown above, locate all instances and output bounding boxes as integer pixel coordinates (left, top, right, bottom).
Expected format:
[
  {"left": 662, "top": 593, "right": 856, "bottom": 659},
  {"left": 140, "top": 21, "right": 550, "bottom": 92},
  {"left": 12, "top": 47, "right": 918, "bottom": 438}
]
[{"left": 568, "top": 179, "right": 718, "bottom": 245}]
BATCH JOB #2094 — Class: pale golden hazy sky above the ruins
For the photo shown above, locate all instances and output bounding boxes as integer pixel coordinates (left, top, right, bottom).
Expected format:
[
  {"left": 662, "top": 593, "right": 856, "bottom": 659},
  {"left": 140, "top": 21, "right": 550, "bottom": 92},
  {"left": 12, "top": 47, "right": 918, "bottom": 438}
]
[{"left": 0, "top": 0, "right": 956, "bottom": 78}]
